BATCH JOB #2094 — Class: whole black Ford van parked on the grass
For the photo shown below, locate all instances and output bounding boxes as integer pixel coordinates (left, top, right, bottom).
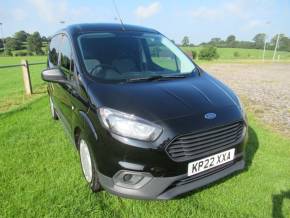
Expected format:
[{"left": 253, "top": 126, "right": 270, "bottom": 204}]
[{"left": 42, "top": 24, "right": 247, "bottom": 199}]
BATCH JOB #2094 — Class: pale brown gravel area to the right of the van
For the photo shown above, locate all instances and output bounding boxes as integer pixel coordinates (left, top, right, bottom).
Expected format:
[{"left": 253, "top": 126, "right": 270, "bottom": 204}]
[{"left": 202, "top": 63, "right": 290, "bottom": 136}]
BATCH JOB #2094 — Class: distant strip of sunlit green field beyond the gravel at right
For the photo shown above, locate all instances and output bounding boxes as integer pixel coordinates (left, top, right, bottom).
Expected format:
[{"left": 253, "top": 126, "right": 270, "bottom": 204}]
[{"left": 182, "top": 47, "right": 290, "bottom": 61}]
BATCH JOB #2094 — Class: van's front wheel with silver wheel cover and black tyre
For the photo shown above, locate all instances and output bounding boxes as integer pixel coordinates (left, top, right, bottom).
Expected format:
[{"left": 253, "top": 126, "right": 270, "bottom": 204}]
[{"left": 78, "top": 135, "right": 101, "bottom": 192}]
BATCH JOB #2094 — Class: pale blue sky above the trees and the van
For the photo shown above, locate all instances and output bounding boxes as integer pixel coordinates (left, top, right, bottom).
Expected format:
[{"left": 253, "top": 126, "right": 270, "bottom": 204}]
[{"left": 0, "top": 0, "right": 290, "bottom": 44}]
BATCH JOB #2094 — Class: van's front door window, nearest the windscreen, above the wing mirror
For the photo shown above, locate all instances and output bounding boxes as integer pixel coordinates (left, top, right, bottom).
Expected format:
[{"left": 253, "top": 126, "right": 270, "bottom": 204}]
[{"left": 60, "top": 35, "right": 74, "bottom": 79}]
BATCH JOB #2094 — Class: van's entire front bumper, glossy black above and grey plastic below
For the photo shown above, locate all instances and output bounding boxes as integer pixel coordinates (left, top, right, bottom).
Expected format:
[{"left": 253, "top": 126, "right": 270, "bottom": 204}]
[{"left": 91, "top": 107, "right": 247, "bottom": 199}]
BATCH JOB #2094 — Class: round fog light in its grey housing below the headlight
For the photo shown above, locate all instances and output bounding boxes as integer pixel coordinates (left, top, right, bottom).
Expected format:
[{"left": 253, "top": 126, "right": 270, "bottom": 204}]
[{"left": 113, "top": 170, "right": 152, "bottom": 189}]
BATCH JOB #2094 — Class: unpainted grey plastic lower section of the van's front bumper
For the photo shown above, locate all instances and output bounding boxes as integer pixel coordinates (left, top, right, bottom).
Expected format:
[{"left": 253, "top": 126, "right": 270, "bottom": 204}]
[{"left": 98, "top": 154, "right": 245, "bottom": 200}]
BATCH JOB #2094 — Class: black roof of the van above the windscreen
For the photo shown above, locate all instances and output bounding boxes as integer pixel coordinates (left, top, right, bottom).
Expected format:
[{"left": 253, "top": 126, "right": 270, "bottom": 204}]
[{"left": 63, "top": 23, "right": 158, "bottom": 35}]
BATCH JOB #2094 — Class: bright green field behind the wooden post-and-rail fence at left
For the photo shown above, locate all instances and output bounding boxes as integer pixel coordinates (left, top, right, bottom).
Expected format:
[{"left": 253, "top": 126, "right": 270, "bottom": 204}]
[{"left": 0, "top": 56, "right": 46, "bottom": 113}]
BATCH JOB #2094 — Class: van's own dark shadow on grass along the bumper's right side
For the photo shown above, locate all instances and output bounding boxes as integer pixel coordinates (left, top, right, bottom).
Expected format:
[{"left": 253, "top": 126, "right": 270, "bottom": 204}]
[{"left": 176, "top": 126, "right": 259, "bottom": 199}]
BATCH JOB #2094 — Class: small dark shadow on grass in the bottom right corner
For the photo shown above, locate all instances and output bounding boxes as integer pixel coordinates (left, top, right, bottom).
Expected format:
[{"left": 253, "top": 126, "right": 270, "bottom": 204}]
[{"left": 272, "top": 190, "right": 290, "bottom": 218}]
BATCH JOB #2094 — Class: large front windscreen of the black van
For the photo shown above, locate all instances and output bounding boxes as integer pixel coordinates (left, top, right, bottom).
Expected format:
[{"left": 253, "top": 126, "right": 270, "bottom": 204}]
[{"left": 77, "top": 32, "right": 195, "bottom": 82}]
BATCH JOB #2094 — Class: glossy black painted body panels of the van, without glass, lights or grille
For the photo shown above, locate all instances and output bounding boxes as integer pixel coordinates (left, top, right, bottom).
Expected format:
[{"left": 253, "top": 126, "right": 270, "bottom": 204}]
[{"left": 48, "top": 24, "right": 244, "bottom": 198}]
